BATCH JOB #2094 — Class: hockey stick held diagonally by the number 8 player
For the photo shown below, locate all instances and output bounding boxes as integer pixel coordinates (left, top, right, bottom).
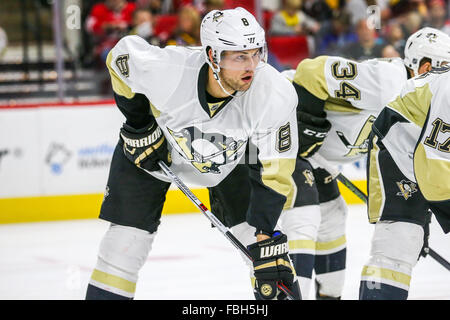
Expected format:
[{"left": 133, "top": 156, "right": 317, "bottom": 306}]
[{"left": 141, "top": 161, "right": 296, "bottom": 300}]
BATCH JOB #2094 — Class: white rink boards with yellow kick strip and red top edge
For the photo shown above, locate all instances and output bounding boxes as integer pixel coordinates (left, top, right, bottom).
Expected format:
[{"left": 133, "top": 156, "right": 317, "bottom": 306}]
[{"left": 0, "top": 101, "right": 365, "bottom": 223}]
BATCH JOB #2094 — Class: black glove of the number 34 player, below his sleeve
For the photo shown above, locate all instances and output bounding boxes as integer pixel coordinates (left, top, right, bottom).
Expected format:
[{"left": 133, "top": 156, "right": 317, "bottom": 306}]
[{"left": 297, "top": 111, "right": 331, "bottom": 158}]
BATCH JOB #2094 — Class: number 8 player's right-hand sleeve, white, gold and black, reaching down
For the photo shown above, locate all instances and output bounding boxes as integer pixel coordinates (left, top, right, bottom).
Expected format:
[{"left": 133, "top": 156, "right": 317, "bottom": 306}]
[{"left": 248, "top": 75, "right": 298, "bottom": 232}]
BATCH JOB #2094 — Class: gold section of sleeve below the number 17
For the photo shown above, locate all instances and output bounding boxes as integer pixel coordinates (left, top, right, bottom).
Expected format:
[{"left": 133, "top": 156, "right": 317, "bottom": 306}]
[{"left": 414, "top": 143, "right": 450, "bottom": 201}]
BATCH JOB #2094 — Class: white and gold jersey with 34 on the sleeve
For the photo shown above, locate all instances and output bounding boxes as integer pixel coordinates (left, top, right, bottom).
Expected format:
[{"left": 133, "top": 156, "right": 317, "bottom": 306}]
[{"left": 285, "top": 56, "right": 407, "bottom": 163}]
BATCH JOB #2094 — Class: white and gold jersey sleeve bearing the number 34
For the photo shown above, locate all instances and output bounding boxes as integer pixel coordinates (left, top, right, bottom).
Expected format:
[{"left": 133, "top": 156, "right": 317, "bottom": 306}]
[{"left": 294, "top": 56, "right": 406, "bottom": 113}]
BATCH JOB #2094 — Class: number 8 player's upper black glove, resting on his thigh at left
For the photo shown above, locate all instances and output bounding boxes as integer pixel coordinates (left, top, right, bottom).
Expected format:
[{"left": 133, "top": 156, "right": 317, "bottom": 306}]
[{"left": 120, "top": 121, "right": 172, "bottom": 171}]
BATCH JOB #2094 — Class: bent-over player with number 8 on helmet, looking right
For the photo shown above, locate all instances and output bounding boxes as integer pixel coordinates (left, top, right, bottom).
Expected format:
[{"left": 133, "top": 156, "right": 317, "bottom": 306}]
[{"left": 86, "top": 8, "right": 300, "bottom": 299}]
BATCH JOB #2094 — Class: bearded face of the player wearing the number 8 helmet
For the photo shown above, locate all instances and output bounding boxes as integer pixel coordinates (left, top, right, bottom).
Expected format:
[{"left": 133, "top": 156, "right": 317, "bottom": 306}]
[{"left": 220, "top": 49, "right": 261, "bottom": 91}]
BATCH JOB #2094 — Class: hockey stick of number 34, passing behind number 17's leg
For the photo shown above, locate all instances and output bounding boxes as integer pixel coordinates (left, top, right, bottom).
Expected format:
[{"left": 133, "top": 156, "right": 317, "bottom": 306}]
[{"left": 311, "top": 153, "right": 450, "bottom": 271}]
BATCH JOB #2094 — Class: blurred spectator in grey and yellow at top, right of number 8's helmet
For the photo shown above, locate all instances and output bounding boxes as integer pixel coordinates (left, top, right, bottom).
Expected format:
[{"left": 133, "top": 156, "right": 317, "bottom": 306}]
[{"left": 270, "top": 0, "right": 320, "bottom": 36}]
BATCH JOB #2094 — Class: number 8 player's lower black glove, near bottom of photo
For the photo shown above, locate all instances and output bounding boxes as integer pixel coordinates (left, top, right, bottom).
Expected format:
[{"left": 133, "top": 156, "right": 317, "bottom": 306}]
[{"left": 248, "top": 231, "right": 295, "bottom": 300}]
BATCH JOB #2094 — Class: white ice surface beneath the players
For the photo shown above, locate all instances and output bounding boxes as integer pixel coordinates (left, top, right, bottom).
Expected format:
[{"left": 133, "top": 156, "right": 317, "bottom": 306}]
[{"left": 0, "top": 205, "right": 450, "bottom": 300}]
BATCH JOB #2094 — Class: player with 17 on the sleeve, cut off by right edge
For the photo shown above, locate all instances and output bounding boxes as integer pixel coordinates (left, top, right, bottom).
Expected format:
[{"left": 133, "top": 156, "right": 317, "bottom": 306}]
[{"left": 359, "top": 62, "right": 450, "bottom": 300}]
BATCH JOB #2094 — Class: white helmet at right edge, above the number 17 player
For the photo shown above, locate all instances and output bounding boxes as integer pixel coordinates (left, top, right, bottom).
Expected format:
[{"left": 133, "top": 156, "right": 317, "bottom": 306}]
[{"left": 403, "top": 27, "right": 450, "bottom": 76}]
